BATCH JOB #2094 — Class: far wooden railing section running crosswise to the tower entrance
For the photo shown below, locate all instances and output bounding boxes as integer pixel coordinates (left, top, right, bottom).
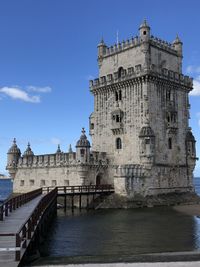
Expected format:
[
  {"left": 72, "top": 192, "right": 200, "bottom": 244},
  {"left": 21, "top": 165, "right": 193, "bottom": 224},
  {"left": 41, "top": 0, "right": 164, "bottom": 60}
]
[{"left": 42, "top": 184, "right": 114, "bottom": 194}]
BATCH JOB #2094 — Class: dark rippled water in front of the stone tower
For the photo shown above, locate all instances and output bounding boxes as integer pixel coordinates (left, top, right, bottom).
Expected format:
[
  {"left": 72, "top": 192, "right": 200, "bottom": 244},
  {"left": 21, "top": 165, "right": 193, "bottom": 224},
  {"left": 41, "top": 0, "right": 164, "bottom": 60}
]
[{"left": 34, "top": 179, "right": 200, "bottom": 264}]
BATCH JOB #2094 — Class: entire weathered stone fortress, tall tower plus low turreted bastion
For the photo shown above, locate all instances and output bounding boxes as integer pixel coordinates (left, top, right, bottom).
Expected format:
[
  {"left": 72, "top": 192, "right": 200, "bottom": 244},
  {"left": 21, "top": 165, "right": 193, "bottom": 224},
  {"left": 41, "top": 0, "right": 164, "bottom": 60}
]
[{"left": 7, "top": 22, "right": 196, "bottom": 199}]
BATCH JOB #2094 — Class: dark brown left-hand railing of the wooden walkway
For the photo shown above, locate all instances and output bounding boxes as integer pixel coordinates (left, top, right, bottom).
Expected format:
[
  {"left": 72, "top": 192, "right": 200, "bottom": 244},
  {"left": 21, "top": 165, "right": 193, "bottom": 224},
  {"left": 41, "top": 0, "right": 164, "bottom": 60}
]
[{"left": 0, "top": 188, "right": 42, "bottom": 221}]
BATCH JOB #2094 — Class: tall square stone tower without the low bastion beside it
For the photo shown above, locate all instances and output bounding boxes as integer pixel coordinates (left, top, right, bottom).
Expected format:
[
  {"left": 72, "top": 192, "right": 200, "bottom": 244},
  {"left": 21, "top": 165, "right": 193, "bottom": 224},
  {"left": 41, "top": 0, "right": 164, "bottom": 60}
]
[{"left": 90, "top": 20, "right": 196, "bottom": 195}]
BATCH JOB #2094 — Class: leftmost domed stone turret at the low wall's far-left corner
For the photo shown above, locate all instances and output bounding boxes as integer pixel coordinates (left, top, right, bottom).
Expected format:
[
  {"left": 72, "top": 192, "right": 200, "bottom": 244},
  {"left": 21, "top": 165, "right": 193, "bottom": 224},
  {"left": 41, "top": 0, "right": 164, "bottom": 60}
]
[{"left": 6, "top": 138, "right": 21, "bottom": 178}]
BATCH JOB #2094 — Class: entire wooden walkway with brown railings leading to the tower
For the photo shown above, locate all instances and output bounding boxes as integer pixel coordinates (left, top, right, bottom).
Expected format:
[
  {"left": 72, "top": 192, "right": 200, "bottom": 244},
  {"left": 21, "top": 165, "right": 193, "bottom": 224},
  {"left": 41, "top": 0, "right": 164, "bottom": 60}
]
[{"left": 0, "top": 185, "right": 114, "bottom": 267}]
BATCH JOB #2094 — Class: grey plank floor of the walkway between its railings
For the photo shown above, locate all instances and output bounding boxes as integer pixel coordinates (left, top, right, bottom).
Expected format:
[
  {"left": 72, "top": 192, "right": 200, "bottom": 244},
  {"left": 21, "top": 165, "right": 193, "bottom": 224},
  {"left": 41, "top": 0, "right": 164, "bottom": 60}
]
[{"left": 0, "top": 195, "right": 44, "bottom": 267}]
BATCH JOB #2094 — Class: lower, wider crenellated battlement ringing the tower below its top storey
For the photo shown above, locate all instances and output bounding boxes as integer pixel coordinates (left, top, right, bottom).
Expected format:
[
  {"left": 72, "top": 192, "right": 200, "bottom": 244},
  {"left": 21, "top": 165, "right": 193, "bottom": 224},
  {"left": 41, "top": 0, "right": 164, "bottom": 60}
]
[{"left": 90, "top": 65, "right": 193, "bottom": 92}]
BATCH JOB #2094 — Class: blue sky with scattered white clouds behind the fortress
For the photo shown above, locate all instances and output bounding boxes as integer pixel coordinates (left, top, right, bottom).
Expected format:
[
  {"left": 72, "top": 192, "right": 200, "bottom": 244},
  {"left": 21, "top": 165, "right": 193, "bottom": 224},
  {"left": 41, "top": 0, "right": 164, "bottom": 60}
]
[{"left": 0, "top": 0, "right": 200, "bottom": 176}]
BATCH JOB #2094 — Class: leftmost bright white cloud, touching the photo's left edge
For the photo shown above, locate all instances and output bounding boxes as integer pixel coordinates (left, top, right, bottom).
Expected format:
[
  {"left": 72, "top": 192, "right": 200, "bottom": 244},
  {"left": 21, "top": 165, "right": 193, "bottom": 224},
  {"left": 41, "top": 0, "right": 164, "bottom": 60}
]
[{"left": 0, "top": 87, "right": 40, "bottom": 103}]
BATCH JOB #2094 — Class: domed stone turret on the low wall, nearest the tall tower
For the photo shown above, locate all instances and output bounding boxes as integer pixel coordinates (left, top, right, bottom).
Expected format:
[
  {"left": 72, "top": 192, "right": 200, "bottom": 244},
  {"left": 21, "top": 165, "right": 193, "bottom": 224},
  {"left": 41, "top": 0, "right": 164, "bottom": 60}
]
[{"left": 76, "top": 128, "right": 90, "bottom": 163}]
